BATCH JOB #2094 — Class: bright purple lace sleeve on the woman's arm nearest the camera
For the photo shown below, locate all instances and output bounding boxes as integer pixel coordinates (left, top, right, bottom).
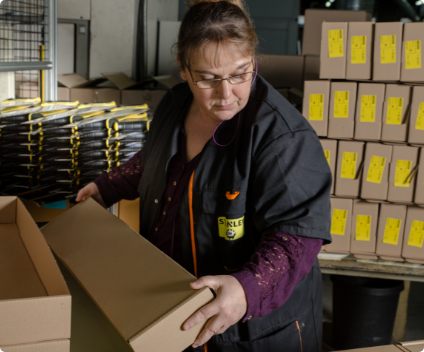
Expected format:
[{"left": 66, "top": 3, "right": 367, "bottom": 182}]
[{"left": 232, "top": 232, "right": 323, "bottom": 321}]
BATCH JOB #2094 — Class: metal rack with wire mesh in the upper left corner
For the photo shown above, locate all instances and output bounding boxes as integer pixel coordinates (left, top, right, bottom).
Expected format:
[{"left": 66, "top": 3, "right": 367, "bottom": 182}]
[{"left": 0, "top": 0, "right": 57, "bottom": 101}]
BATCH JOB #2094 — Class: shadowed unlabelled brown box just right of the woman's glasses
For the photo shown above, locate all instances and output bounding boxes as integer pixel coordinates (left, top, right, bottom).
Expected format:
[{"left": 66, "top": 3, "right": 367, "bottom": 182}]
[{"left": 259, "top": 55, "right": 305, "bottom": 91}]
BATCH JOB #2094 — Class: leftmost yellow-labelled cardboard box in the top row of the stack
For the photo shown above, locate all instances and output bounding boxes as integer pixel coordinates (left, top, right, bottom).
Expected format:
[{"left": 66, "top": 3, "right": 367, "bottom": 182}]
[{"left": 319, "top": 22, "right": 348, "bottom": 79}]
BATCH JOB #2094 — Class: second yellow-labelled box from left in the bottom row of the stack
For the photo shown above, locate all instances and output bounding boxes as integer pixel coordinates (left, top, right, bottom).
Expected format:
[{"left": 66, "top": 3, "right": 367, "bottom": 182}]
[{"left": 350, "top": 199, "right": 380, "bottom": 259}]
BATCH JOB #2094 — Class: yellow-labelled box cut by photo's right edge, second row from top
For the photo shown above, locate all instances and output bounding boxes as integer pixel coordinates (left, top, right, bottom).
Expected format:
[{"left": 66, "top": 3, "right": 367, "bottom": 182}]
[{"left": 408, "top": 86, "right": 424, "bottom": 145}]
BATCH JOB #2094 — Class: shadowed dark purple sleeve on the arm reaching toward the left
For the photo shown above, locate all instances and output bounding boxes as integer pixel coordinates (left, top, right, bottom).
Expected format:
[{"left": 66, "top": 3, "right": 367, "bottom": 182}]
[{"left": 94, "top": 151, "right": 143, "bottom": 207}]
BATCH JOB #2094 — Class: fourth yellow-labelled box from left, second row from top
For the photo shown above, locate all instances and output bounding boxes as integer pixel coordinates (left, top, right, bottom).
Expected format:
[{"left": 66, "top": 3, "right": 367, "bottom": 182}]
[{"left": 381, "top": 84, "right": 411, "bottom": 143}]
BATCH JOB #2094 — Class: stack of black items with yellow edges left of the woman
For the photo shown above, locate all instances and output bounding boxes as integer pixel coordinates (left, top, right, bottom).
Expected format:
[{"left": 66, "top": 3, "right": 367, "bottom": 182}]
[{"left": 0, "top": 98, "right": 150, "bottom": 206}]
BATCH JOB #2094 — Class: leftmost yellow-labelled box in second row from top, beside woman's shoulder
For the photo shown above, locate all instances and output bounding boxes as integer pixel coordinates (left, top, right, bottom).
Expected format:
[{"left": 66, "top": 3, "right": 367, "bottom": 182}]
[{"left": 303, "top": 81, "right": 330, "bottom": 137}]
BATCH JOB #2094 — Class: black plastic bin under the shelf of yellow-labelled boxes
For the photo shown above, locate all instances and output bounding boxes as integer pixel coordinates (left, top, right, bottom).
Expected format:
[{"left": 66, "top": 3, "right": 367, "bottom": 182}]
[{"left": 331, "top": 275, "right": 404, "bottom": 350}]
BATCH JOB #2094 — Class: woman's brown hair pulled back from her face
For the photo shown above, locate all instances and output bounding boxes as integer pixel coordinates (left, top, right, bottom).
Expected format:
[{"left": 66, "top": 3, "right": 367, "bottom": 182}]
[{"left": 176, "top": 0, "right": 258, "bottom": 69}]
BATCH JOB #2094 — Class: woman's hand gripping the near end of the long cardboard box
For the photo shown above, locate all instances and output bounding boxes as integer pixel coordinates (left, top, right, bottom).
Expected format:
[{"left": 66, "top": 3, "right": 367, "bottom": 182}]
[{"left": 183, "top": 275, "right": 247, "bottom": 348}]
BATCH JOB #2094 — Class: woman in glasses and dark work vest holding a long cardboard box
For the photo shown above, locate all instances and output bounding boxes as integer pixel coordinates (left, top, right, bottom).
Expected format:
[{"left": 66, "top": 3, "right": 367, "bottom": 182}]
[{"left": 77, "top": 0, "right": 331, "bottom": 352}]
